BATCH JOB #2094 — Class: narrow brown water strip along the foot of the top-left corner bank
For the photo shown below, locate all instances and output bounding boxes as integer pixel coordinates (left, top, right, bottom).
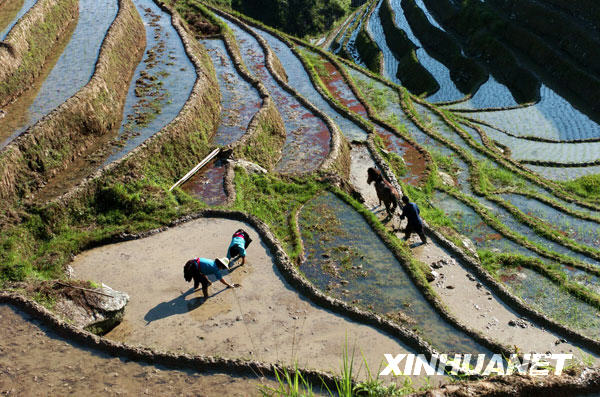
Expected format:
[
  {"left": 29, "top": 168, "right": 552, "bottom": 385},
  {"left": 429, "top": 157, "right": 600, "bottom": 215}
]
[{"left": 0, "top": 17, "right": 77, "bottom": 146}]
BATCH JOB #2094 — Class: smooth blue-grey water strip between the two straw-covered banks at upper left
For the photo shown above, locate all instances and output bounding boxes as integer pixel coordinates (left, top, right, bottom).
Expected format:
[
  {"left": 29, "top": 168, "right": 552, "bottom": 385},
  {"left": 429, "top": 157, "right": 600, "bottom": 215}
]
[{"left": 0, "top": 0, "right": 118, "bottom": 147}]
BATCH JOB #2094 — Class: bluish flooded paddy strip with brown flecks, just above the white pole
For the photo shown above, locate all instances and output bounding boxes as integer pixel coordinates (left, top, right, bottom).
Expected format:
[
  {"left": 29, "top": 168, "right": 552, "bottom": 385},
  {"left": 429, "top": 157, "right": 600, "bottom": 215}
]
[{"left": 200, "top": 39, "right": 262, "bottom": 146}]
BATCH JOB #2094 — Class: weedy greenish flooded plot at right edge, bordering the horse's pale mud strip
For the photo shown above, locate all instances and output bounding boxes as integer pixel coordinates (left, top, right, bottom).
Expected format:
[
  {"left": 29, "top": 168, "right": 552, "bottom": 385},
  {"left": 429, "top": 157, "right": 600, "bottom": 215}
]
[{"left": 498, "top": 268, "right": 600, "bottom": 339}]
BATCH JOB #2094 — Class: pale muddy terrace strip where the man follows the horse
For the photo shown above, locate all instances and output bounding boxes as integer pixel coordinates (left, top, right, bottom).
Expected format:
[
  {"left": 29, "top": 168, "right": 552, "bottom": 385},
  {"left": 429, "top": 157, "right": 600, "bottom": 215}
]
[{"left": 350, "top": 146, "right": 583, "bottom": 357}]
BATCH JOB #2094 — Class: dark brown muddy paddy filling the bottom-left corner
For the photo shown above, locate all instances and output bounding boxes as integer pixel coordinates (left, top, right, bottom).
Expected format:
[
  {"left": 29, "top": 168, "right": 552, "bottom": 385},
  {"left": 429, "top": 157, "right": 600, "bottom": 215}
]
[{"left": 0, "top": 305, "right": 274, "bottom": 396}]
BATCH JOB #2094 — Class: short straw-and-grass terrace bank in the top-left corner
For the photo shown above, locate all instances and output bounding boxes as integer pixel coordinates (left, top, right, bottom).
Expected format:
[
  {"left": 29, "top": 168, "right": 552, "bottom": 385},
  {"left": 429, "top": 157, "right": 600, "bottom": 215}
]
[{"left": 0, "top": 0, "right": 79, "bottom": 107}]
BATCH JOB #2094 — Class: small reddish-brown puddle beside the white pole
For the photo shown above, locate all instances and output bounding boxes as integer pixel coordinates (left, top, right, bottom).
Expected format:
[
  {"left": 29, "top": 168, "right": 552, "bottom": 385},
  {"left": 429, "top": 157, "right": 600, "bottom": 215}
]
[{"left": 181, "top": 160, "right": 227, "bottom": 205}]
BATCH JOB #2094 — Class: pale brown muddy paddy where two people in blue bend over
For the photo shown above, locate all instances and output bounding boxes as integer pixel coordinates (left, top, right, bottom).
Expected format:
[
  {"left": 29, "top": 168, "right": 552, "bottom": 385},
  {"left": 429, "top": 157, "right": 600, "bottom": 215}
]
[{"left": 72, "top": 219, "right": 414, "bottom": 377}]
